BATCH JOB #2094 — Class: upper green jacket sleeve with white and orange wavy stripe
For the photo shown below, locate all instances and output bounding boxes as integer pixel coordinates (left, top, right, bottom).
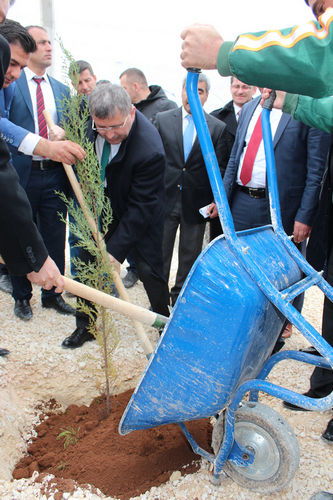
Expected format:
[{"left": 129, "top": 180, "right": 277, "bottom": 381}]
[{"left": 217, "top": 8, "right": 333, "bottom": 98}]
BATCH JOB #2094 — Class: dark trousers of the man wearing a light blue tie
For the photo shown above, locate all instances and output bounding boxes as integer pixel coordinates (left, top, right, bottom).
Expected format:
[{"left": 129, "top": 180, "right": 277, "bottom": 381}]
[{"left": 163, "top": 191, "right": 206, "bottom": 305}]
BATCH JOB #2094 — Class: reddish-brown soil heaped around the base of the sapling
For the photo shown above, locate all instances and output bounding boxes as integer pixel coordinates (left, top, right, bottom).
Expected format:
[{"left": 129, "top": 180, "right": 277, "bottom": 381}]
[{"left": 13, "top": 390, "right": 212, "bottom": 500}]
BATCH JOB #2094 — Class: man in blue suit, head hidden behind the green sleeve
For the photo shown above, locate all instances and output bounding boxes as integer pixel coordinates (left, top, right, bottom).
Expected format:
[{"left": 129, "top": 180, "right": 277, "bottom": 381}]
[{"left": 217, "top": 97, "right": 330, "bottom": 240}]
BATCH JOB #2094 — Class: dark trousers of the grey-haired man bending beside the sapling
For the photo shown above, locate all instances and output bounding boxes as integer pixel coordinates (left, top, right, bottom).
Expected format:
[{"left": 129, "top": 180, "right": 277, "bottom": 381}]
[{"left": 76, "top": 247, "right": 170, "bottom": 328}]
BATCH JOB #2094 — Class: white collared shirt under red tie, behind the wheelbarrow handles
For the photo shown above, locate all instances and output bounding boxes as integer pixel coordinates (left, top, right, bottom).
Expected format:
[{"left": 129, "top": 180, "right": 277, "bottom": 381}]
[{"left": 236, "top": 104, "right": 282, "bottom": 188}]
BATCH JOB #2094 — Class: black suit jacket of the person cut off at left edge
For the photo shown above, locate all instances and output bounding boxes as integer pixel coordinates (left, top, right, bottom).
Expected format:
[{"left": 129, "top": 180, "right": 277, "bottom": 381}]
[{"left": 0, "top": 36, "right": 47, "bottom": 276}]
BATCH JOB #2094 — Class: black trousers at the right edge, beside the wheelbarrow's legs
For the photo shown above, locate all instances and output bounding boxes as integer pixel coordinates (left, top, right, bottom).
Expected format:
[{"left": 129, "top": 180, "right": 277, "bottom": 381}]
[{"left": 309, "top": 246, "right": 333, "bottom": 398}]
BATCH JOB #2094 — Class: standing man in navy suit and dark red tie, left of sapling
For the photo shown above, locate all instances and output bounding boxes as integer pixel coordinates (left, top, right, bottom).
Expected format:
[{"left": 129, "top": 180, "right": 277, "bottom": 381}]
[{"left": 9, "top": 26, "right": 75, "bottom": 320}]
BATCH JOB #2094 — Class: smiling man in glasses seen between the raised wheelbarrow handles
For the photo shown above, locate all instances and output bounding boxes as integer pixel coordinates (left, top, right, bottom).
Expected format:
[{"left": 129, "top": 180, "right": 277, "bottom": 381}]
[{"left": 210, "top": 76, "right": 257, "bottom": 241}]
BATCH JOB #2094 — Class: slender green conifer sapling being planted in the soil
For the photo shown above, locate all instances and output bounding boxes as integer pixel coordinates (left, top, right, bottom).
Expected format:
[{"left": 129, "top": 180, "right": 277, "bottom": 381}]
[{"left": 59, "top": 39, "right": 119, "bottom": 415}]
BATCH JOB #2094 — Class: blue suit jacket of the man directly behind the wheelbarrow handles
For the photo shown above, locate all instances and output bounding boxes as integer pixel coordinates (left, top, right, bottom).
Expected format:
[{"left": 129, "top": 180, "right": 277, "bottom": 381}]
[{"left": 223, "top": 97, "right": 330, "bottom": 235}]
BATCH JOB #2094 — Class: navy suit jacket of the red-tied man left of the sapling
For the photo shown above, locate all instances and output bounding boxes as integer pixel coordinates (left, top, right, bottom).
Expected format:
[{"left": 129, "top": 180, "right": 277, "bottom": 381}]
[{"left": 9, "top": 71, "right": 69, "bottom": 188}]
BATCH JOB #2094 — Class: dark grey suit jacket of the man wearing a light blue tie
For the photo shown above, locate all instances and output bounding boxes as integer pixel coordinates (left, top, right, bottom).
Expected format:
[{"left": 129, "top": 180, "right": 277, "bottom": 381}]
[{"left": 156, "top": 107, "right": 225, "bottom": 224}]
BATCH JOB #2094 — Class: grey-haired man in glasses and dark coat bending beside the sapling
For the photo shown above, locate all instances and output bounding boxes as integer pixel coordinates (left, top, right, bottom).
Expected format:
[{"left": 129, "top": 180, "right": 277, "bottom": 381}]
[{"left": 62, "top": 83, "right": 169, "bottom": 349}]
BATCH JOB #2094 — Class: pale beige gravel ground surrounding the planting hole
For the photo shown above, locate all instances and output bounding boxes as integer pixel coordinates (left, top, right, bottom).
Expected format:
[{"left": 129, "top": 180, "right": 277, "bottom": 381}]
[{"left": 0, "top": 235, "right": 333, "bottom": 500}]
